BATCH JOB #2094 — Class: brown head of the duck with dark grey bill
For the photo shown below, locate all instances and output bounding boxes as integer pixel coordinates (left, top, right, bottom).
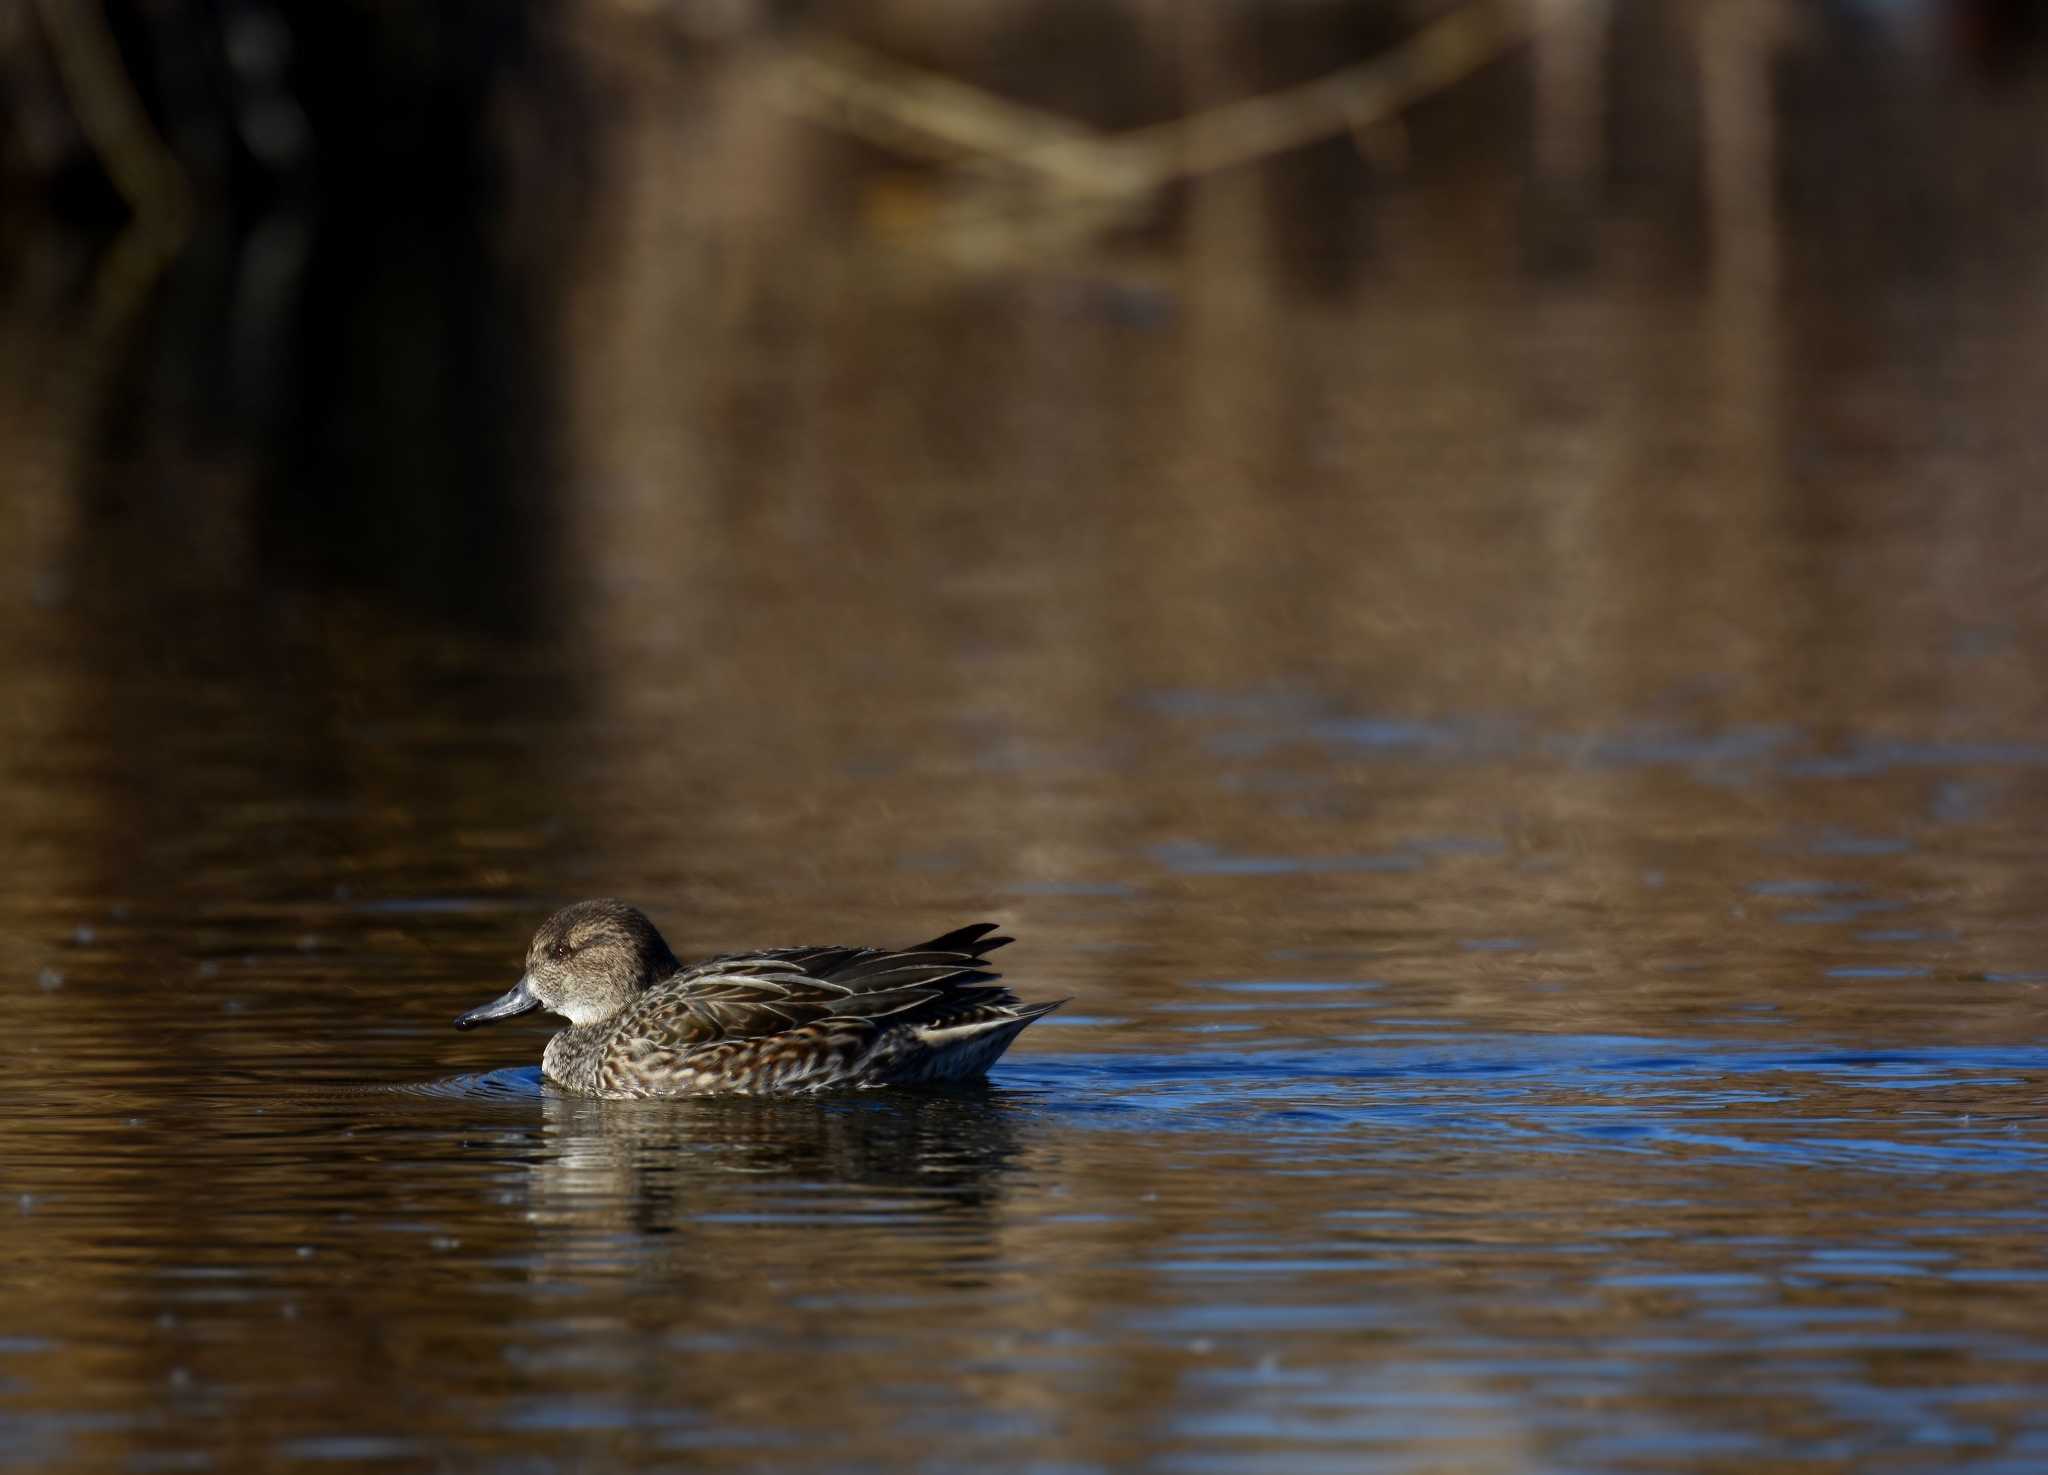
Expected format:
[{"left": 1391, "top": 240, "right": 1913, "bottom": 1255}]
[{"left": 455, "top": 897, "right": 676, "bottom": 1028}]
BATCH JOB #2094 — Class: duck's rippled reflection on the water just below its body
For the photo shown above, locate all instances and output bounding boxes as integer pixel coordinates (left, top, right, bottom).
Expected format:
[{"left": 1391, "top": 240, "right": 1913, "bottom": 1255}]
[{"left": 528, "top": 1086, "right": 1036, "bottom": 1274}]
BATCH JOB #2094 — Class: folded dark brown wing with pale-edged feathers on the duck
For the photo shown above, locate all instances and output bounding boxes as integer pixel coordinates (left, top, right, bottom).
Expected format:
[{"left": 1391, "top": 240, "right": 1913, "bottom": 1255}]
[{"left": 621, "top": 922, "right": 1018, "bottom": 1047}]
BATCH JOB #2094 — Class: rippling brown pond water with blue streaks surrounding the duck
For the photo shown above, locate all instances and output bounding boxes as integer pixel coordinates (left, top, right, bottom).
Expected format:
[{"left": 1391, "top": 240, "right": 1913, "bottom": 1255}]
[{"left": 0, "top": 11, "right": 2048, "bottom": 1475}]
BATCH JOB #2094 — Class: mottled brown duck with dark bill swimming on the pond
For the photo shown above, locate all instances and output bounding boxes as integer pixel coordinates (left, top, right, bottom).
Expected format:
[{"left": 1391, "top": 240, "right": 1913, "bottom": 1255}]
[{"left": 455, "top": 897, "right": 1067, "bottom": 1100}]
